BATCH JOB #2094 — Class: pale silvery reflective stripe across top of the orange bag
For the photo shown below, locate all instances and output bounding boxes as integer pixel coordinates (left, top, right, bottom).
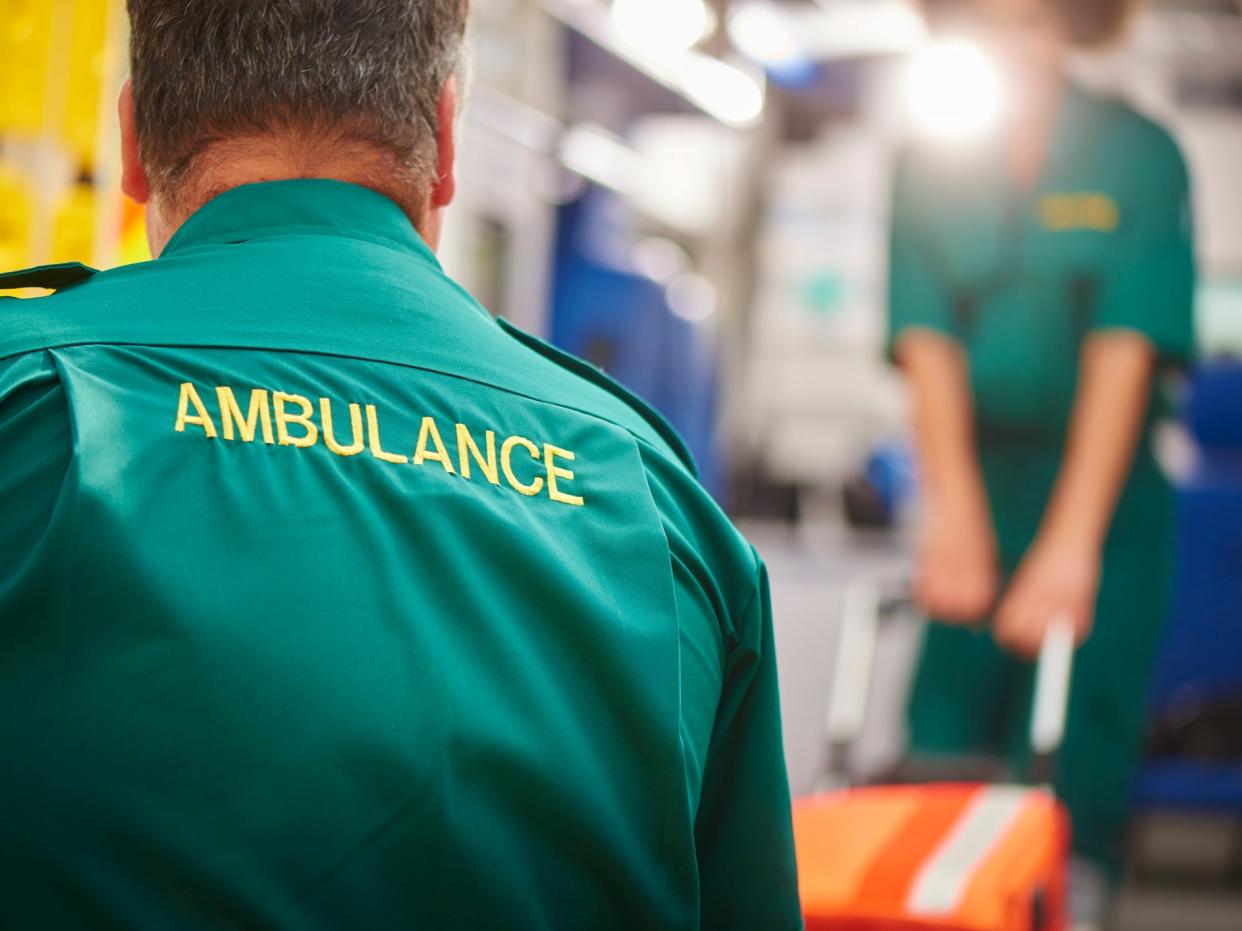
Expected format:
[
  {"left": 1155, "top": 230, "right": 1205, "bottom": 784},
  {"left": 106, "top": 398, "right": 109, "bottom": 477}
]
[{"left": 905, "top": 786, "right": 1031, "bottom": 916}]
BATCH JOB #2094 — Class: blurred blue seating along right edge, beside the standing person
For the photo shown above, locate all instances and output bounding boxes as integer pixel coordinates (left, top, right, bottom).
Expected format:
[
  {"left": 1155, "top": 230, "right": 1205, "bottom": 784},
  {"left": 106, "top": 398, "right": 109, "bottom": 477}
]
[{"left": 1120, "top": 361, "right": 1242, "bottom": 927}]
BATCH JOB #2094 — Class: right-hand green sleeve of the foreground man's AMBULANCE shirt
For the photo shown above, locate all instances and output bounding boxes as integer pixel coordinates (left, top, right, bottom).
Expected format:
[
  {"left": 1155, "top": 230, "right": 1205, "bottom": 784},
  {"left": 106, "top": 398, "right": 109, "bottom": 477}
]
[{"left": 694, "top": 564, "right": 802, "bottom": 931}]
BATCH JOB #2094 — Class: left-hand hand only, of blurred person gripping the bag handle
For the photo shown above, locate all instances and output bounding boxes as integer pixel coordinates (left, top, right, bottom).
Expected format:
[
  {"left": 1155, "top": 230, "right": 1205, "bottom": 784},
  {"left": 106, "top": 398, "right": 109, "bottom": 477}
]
[{"left": 915, "top": 509, "right": 1000, "bottom": 624}]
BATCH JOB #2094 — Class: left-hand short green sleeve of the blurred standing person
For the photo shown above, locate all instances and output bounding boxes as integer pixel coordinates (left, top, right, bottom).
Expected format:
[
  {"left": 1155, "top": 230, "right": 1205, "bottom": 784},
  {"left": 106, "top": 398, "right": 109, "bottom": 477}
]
[{"left": 886, "top": 153, "right": 958, "bottom": 359}]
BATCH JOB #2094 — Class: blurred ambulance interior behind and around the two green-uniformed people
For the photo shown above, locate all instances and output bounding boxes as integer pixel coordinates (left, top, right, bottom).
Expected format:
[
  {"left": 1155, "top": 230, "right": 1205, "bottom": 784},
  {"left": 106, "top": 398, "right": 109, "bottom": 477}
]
[{"left": 0, "top": 0, "right": 1242, "bottom": 931}]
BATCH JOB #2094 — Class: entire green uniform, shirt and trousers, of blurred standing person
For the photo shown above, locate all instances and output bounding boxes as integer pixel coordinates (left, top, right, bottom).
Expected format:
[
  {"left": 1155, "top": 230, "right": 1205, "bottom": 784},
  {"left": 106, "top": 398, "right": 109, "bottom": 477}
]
[{"left": 889, "top": 87, "right": 1195, "bottom": 864}]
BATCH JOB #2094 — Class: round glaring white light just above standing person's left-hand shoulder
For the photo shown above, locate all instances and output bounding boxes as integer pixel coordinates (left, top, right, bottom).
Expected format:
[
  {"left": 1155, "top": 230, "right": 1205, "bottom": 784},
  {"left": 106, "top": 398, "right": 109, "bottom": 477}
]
[{"left": 905, "top": 41, "right": 1005, "bottom": 140}]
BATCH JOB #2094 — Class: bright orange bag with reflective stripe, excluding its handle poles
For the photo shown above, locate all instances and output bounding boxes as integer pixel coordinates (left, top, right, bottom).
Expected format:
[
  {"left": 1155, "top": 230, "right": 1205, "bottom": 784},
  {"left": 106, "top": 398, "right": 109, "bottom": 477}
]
[{"left": 794, "top": 785, "right": 1069, "bottom": 931}]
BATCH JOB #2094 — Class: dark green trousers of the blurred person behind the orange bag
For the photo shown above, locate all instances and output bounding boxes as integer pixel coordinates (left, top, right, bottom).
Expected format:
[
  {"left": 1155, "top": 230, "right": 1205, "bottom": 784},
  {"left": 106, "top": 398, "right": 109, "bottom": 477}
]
[{"left": 909, "top": 444, "right": 1174, "bottom": 870}]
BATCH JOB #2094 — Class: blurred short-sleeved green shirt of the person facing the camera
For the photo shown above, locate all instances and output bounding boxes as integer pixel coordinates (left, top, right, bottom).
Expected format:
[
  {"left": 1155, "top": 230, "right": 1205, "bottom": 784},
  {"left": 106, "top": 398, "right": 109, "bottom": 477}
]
[{"left": 889, "top": 86, "right": 1195, "bottom": 559}]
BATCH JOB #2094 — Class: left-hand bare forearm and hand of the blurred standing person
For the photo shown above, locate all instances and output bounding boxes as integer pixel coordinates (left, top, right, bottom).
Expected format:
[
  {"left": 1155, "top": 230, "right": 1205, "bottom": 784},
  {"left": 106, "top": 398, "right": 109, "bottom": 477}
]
[{"left": 894, "top": 329, "right": 997, "bottom": 622}]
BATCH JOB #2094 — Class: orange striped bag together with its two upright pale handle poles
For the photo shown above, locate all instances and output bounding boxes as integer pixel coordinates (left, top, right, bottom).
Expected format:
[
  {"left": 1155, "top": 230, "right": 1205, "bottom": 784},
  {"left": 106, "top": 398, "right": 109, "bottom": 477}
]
[{"left": 794, "top": 587, "right": 1074, "bottom": 931}]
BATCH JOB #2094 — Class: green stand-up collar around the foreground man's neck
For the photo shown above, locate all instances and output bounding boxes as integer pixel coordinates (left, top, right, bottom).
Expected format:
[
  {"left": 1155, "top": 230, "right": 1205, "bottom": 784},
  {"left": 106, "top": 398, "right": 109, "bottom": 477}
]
[{"left": 160, "top": 179, "right": 440, "bottom": 269}]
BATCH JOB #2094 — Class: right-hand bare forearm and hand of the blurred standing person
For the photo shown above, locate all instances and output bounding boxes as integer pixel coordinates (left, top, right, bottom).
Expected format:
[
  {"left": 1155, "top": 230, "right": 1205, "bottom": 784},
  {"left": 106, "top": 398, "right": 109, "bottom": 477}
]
[{"left": 995, "top": 330, "right": 1156, "bottom": 655}]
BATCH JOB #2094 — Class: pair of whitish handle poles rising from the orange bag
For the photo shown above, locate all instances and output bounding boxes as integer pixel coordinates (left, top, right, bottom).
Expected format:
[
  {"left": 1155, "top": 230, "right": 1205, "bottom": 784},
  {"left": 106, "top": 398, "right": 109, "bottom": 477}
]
[{"left": 820, "top": 583, "right": 1076, "bottom": 788}]
